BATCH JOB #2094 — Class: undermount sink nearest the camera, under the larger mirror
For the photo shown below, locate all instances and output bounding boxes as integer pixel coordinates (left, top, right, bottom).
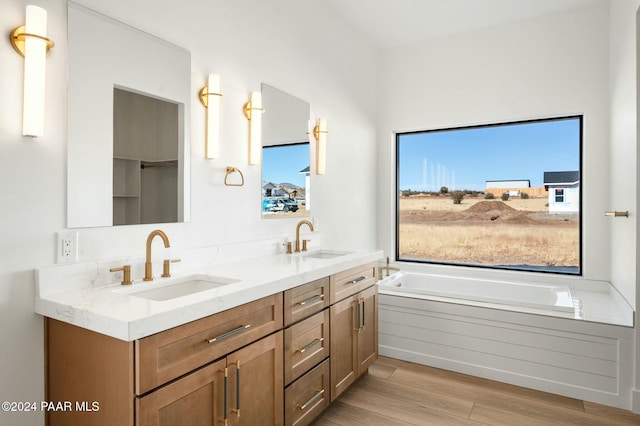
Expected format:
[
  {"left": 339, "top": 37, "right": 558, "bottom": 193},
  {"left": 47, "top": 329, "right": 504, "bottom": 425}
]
[{"left": 115, "top": 275, "right": 239, "bottom": 301}]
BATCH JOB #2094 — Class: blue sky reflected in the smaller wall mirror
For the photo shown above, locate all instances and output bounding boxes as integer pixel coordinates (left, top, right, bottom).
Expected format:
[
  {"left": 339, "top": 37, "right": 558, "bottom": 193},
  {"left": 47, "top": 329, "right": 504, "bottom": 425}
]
[{"left": 262, "top": 143, "right": 309, "bottom": 186}]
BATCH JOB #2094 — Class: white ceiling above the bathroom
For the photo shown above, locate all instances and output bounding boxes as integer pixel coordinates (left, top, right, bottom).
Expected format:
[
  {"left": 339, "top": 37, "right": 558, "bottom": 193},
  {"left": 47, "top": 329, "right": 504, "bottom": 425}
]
[{"left": 326, "top": 0, "right": 602, "bottom": 49}]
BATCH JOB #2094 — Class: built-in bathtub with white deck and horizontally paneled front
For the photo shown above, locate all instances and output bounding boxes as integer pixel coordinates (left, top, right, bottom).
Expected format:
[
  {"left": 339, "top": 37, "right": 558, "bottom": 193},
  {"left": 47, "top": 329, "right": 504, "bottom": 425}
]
[{"left": 378, "top": 272, "right": 634, "bottom": 410}]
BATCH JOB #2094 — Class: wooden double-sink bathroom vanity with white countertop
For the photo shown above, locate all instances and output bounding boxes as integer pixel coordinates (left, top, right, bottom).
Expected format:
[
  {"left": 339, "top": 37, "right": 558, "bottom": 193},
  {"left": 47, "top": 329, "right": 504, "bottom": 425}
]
[{"left": 36, "top": 248, "right": 380, "bottom": 426}]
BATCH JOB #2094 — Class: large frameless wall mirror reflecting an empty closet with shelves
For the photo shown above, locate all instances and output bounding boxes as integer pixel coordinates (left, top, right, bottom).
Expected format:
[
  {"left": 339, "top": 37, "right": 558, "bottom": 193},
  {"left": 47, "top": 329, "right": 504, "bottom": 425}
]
[{"left": 67, "top": 2, "right": 191, "bottom": 228}]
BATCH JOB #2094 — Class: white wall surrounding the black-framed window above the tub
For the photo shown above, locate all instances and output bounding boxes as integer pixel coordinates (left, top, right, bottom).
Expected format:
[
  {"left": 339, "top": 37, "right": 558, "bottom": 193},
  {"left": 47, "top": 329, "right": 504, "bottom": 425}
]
[{"left": 378, "top": 2, "right": 612, "bottom": 280}]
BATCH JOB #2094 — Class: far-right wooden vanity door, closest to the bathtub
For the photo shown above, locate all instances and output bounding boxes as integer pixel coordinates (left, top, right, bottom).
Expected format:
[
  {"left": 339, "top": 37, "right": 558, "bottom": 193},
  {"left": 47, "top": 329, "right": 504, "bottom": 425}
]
[{"left": 357, "top": 286, "right": 378, "bottom": 375}]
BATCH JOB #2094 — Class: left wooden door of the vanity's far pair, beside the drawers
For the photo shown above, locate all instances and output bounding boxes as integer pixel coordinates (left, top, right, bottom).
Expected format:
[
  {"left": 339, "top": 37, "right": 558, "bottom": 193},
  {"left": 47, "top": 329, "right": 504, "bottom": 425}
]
[{"left": 330, "top": 297, "right": 358, "bottom": 401}]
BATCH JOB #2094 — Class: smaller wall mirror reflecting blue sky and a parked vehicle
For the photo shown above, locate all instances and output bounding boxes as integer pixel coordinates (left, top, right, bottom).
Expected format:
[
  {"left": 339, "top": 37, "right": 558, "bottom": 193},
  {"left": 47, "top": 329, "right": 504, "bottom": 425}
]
[{"left": 262, "top": 83, "right": 311, "bottom": 219}]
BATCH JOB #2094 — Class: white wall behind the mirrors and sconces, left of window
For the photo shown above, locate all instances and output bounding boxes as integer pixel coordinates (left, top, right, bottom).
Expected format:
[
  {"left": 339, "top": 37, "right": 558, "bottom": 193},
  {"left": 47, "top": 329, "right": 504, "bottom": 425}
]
[{"left": 0, "top": 0, "right": 377, "bottom": 425}]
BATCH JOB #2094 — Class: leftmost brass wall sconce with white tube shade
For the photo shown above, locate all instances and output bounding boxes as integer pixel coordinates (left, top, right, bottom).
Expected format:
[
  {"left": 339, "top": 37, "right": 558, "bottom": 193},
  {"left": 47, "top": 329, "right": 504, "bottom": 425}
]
[{"left": 9, "top": 5, "right": 54, "bottom": 137}]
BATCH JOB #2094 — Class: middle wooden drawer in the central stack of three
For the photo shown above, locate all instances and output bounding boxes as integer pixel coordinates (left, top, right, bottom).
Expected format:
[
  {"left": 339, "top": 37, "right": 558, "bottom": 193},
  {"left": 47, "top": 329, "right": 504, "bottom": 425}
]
[{"left": 284, "top": 309, "right": 330, "bottom": 384}]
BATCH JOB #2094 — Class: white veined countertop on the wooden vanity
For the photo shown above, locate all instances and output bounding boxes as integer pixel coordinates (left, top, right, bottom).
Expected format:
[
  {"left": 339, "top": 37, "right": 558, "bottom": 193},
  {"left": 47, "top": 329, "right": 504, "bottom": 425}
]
[{"left": 35, "top": 250, "right": 383, "bottom": 341}]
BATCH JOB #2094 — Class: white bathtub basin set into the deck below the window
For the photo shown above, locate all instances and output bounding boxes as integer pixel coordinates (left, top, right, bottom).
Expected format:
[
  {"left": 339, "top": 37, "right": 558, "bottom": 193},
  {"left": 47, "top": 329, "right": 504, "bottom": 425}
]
[{"left": 378, "top": 272, "right": 576, "bottom": 312}]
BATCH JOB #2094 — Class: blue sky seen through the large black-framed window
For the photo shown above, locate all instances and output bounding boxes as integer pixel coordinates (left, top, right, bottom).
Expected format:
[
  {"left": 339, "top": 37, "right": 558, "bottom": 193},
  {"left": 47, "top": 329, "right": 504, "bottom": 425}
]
[{"left": 398, "top": 118, "right": 580, "bottom": 191}]
